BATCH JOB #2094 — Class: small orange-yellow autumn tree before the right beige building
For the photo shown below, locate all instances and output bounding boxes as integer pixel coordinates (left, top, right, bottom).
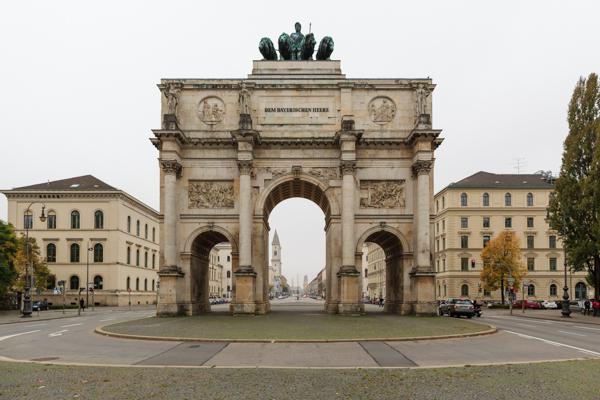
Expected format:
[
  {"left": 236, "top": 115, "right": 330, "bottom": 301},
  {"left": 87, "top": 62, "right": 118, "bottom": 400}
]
[{"left": 481, "top": 231, "right": 527, "bottom": 304}]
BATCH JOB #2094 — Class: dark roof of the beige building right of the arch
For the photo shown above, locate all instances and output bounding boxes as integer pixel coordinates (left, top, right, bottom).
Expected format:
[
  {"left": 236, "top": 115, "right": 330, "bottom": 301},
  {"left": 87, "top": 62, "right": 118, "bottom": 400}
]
[{"left": 448, "top": 171, "right": 554, "bottom": 189}]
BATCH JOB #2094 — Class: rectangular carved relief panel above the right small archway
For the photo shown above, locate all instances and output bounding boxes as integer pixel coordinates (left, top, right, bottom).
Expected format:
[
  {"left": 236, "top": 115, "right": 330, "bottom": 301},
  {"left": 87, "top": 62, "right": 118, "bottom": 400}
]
[{"left": 360, "top": 179, "right": 406, "bottom": 208}]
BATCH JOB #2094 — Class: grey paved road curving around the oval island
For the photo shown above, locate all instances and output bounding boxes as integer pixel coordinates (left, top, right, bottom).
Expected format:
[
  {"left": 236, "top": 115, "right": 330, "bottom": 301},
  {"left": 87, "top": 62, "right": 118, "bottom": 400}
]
[{"left": 0, "top": 301, "right": 600, "bottom": 368}]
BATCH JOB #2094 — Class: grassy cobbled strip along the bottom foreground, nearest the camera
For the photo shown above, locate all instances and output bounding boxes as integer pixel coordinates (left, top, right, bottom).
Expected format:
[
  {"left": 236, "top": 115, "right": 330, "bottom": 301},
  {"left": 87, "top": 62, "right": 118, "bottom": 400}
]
[{"left": 0, "top": 360, "right": 600, "bottom": 400}]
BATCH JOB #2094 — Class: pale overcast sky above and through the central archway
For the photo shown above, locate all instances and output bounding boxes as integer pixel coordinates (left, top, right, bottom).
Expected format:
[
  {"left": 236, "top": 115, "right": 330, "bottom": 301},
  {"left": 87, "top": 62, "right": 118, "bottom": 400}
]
[{"left": 0, "top": 0, "right": 600, "bottom": 280}]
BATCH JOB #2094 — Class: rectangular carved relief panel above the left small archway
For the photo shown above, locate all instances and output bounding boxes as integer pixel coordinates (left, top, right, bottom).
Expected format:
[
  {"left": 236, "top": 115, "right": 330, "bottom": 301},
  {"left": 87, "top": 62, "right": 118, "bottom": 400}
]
[{"left": 188, "top": 181, "right": 234, "bottom": 208}]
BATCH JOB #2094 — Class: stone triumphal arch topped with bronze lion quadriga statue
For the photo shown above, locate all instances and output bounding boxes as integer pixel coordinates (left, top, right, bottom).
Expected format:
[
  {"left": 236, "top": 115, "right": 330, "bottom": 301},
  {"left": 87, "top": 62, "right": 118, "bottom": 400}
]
[{"left": 152, "top": 27, "right": 442, "bottom": 315}]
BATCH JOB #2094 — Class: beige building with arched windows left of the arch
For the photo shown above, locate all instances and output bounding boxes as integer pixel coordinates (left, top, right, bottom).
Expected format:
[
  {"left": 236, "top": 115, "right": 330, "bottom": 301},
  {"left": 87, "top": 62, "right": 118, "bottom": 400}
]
[{"left": 2, "top": 175, "right": 159, "bottom": 306}]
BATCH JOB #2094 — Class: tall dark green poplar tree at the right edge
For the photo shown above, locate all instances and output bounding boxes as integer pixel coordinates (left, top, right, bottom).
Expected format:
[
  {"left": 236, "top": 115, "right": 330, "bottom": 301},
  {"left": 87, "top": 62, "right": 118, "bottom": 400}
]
[{"left": 548, "top": 74, "right": 600, "bottom": 299}]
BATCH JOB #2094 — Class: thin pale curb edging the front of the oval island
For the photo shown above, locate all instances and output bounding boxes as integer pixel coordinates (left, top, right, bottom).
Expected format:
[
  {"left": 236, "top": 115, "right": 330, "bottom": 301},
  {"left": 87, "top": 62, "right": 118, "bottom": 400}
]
[{"left": 94, "top": 324, "right": 497, "bottom": 343}]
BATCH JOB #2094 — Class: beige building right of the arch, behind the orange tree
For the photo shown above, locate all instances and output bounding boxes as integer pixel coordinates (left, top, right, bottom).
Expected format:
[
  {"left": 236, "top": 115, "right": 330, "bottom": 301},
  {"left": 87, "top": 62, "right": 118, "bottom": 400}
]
[{"left": 433, "top": 171, "right": 590, "bottom": 300}]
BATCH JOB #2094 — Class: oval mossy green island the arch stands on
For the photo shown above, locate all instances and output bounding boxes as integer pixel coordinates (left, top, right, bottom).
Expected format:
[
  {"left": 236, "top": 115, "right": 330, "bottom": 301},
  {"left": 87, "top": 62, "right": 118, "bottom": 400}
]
[{"left": 99, "top": 311, "right": 489, "bottom": 340}]
